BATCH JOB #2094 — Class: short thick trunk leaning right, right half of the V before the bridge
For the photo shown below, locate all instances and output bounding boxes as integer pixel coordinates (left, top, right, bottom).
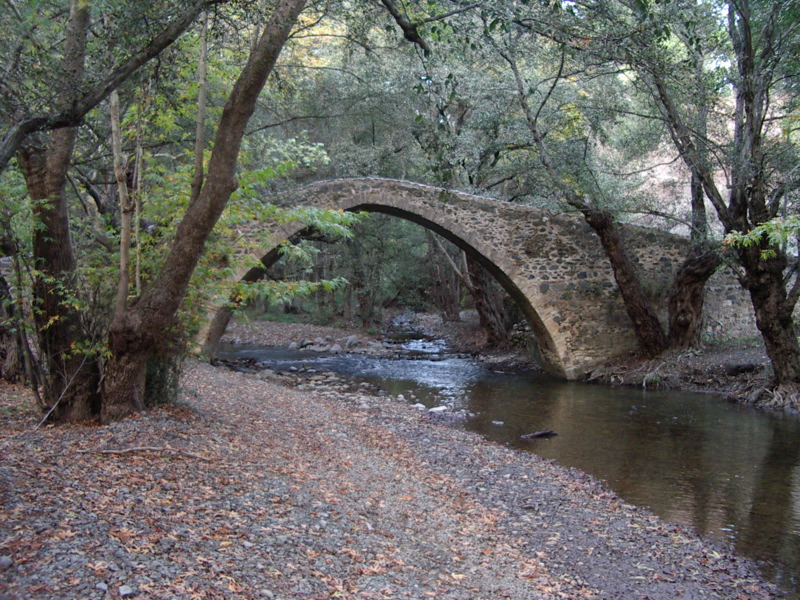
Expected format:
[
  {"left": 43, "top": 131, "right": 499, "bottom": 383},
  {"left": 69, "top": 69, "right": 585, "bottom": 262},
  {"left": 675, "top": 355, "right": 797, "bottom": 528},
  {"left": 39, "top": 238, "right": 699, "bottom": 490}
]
[{"left": 667, "top": 246, "right": 720, "bottom": 348}]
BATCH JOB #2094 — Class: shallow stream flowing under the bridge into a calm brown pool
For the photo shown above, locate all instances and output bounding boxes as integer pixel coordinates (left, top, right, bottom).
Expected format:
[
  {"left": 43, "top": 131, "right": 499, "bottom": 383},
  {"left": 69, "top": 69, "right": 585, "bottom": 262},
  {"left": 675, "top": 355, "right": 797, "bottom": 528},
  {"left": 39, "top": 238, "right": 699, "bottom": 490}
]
[{"left": 216, "top": 332, "right": 800, "bottom": 598}]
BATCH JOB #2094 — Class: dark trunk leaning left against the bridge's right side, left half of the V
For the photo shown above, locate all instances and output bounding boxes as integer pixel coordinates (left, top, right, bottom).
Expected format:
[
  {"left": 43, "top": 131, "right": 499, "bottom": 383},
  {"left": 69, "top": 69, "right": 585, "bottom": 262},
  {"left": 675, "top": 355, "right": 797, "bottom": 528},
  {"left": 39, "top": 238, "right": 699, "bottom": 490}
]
[{"left": 581, "top": 206, "right": 667, "bottom": 358}]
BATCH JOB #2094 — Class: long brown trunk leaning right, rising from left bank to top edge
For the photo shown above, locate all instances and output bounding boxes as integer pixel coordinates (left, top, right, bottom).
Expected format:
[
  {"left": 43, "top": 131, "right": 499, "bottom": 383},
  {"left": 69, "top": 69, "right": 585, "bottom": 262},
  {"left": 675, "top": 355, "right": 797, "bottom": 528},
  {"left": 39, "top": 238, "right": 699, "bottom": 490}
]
[{"left": 102, "top": 0, "right": 305, "bottom": 421}]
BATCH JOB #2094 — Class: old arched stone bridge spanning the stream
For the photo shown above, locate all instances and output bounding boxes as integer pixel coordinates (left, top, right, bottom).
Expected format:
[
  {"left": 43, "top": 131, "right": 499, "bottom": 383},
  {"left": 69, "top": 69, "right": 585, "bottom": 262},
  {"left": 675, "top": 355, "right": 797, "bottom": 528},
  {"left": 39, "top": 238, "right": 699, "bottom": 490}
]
[{"left": 202, "top": 178, "right": 750, "bottom": 379}]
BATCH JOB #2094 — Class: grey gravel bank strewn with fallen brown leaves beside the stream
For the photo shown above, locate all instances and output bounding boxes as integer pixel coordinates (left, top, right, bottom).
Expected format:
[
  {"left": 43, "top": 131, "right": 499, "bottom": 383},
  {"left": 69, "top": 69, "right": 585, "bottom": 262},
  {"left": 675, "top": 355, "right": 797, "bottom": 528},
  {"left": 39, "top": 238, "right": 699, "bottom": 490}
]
[{"left": 0, "top": 363, "right": 780, "bottom": 600}]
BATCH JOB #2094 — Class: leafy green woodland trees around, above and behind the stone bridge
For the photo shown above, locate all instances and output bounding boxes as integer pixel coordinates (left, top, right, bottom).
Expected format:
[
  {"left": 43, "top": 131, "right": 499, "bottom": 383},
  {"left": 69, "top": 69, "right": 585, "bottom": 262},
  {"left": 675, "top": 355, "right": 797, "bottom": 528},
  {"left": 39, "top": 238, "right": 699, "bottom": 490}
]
[{"left": 0, "top": 0, "right": 800, "bottom": 421}]
